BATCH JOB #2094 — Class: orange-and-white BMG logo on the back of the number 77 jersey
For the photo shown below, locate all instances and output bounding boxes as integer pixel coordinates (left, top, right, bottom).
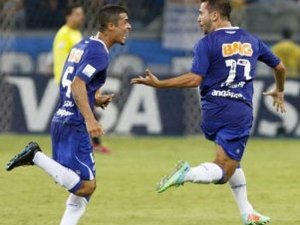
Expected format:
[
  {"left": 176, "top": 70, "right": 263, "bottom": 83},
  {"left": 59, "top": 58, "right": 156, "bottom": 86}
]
[{"left": 222, "top": 42, "right": 253, "bottom": 57}]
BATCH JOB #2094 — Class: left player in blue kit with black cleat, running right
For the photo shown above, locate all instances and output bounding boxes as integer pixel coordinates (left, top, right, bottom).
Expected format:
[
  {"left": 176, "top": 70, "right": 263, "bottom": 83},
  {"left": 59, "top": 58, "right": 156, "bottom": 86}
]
[{"left": 6, "top": 6, "right": 131, "bottom": 225}]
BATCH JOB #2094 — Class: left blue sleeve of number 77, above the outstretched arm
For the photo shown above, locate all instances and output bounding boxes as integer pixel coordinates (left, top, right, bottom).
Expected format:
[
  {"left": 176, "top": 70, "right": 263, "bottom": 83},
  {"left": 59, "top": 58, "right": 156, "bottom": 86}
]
[{"left": 191, "top": 39, "right": 210, "bottom": 77}]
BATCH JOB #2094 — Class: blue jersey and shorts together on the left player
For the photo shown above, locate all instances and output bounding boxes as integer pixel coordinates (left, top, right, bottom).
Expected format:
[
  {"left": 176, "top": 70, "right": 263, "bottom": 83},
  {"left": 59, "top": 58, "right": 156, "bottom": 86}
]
[{"left": 51, "top": 38, "right": 108, "bottom": 181}]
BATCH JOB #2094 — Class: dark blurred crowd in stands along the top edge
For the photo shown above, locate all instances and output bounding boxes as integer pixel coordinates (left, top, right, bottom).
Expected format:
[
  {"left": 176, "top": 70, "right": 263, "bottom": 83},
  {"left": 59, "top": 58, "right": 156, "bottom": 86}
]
[{"left": 0, "top": 0, "right": 300, "bottom": 30}]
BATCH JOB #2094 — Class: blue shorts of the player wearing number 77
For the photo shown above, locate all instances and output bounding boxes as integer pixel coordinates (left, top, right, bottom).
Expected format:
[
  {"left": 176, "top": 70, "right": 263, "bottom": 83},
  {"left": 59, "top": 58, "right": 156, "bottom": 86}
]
[{"left": 201, "top": 98, "right": 253, "bottom": 161}]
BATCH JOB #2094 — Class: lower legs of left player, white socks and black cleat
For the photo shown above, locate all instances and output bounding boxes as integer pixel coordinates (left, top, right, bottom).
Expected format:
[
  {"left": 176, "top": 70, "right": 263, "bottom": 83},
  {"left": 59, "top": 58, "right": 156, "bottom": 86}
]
[{"left": 7, "top": 142, "right": 96, "bottom": 225}]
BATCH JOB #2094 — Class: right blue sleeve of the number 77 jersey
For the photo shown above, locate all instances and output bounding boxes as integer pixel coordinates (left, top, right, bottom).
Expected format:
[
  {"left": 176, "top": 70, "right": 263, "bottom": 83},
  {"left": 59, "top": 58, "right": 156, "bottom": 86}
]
[{"left": 258, "top": 39, "right": 280, "bottom": 68}]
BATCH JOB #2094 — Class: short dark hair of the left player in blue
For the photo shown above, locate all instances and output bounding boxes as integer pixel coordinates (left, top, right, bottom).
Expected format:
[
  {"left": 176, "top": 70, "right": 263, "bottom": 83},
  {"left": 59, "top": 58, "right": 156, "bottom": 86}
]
[{"left": 99, "top": 5, "right": 128, "bottom": 32}]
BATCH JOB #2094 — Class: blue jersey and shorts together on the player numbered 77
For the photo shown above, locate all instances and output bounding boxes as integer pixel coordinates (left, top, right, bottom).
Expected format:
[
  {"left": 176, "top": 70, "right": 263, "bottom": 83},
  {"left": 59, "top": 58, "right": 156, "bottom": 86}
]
[{"left": 191, "top": 27, "right": 280, "bottom": 161}]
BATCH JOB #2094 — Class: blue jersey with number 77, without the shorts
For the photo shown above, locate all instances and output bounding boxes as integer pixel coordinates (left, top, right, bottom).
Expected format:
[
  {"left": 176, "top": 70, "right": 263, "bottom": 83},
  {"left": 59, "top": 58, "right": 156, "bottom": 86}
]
[{"left": 191, "top": 27, "right": 280, "bottom": 106}]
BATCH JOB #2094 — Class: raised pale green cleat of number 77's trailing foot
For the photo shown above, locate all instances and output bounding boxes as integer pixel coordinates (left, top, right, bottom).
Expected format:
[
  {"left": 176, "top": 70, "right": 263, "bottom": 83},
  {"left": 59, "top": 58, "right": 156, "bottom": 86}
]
[{"left": 156, "top": 161, "right": 190, "bottom": 193}]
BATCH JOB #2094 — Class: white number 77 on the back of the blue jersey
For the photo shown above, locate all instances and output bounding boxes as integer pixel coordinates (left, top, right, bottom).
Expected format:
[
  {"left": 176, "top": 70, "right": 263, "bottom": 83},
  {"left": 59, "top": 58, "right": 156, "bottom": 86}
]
[{"left": 225, "top": 59, "right": 252, "bottom": 83}]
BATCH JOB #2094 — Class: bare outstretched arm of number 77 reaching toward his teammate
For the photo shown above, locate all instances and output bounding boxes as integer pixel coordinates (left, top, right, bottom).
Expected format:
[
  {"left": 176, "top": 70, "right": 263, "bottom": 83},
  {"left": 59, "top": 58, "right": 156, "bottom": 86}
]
[{"left": 131, "top": 69, "right": 203, "bottom": 88}]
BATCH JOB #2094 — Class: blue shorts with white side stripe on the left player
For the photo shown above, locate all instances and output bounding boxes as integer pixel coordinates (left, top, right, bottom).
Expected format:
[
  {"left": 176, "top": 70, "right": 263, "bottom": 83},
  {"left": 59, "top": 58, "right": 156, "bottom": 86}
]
[{"left": 51, "top": 122, "right": 96, "bottom": 180}]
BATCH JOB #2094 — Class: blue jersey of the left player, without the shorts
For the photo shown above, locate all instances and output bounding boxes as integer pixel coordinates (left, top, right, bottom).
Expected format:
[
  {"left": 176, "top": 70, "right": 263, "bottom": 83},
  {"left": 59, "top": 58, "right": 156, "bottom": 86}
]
[{"left": 53, "top": 37, "right": 109, "bottom": 126}]
